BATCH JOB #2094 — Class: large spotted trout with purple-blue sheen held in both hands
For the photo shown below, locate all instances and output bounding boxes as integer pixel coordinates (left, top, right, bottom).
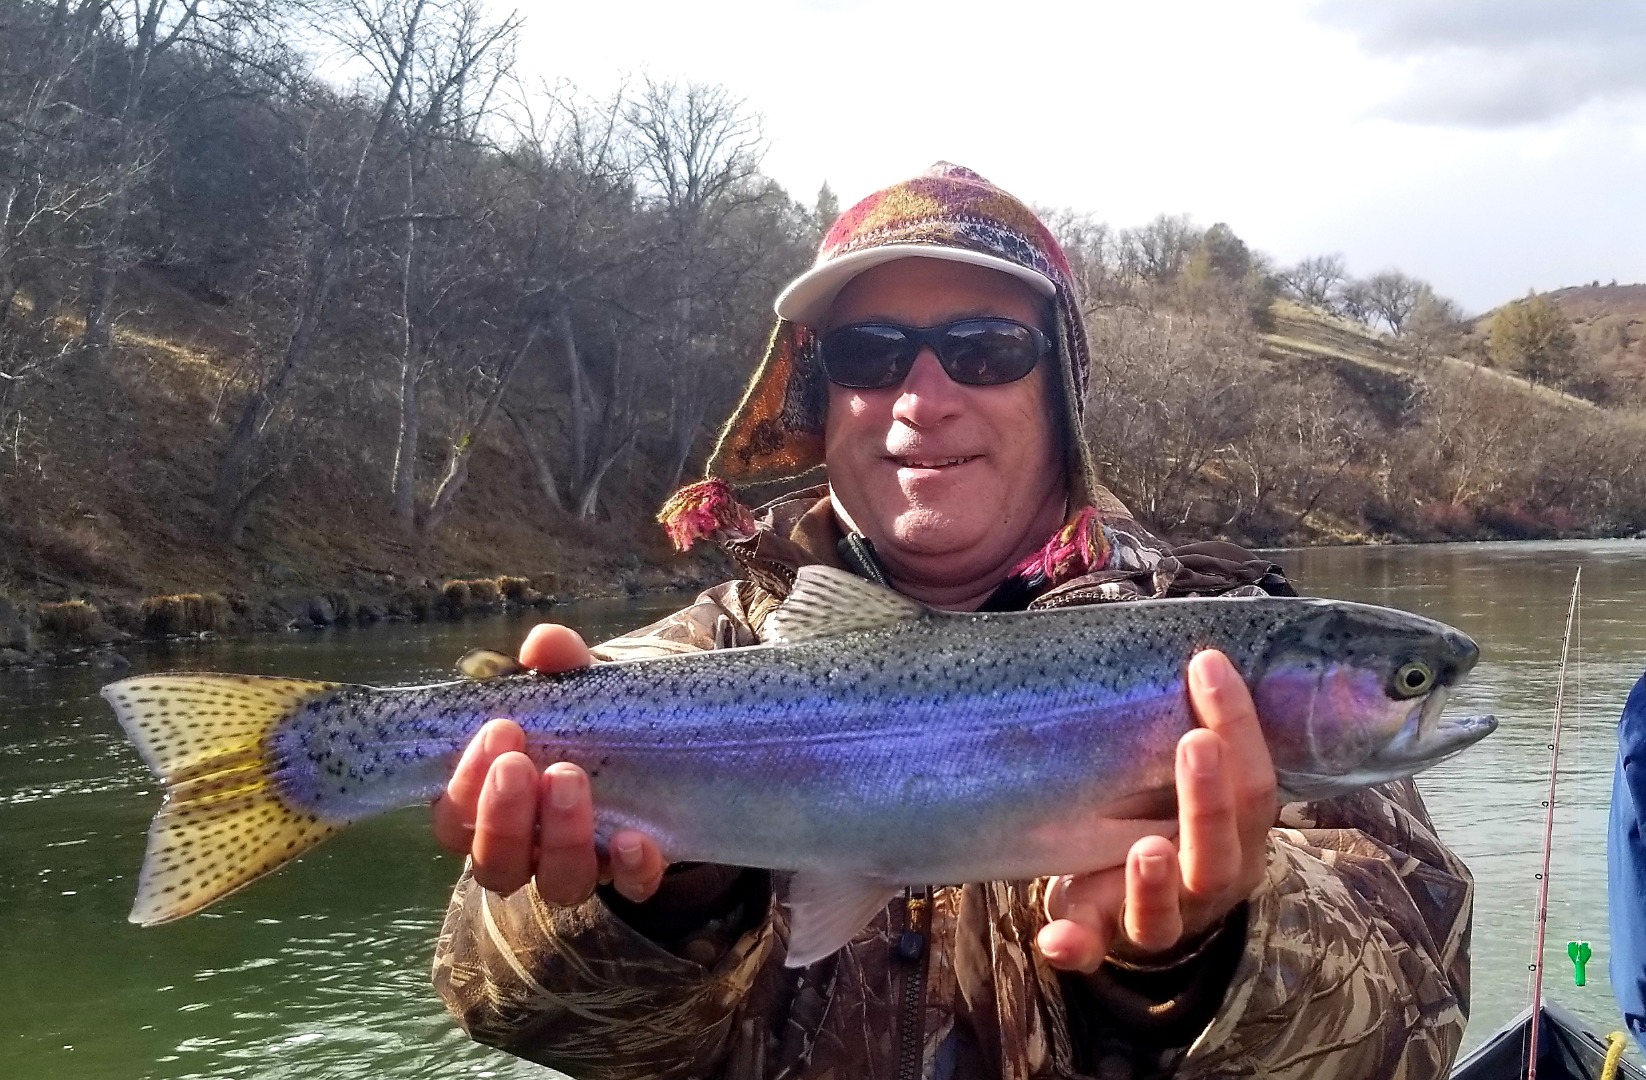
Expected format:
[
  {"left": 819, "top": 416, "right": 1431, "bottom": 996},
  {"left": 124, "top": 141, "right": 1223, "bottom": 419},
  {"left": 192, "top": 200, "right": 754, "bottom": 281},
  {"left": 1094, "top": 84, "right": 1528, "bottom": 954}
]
[{"left": 102, "top": 566, "right": 1496, "bottom": 965}]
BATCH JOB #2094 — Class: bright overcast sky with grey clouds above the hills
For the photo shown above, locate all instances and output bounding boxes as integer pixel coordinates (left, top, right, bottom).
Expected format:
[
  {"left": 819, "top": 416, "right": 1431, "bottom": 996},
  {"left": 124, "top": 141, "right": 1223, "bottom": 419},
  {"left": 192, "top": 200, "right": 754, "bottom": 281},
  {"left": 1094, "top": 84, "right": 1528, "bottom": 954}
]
[{"left": 520, "top": 0, "right": 1646, "bottom": 313}]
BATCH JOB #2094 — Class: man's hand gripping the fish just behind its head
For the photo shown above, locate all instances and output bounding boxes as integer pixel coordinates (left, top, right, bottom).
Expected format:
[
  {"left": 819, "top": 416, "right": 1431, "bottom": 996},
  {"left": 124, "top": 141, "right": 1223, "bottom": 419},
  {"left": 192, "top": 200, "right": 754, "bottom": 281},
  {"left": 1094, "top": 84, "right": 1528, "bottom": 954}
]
[{"left": 1039, "top": 650, "right": 1279, "bottom": 973}]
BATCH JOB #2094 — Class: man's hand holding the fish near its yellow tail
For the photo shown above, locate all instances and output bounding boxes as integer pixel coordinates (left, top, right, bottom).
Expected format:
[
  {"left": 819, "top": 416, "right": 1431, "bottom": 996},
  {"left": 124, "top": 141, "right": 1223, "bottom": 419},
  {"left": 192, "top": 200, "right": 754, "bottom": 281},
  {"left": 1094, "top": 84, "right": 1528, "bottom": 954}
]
[{"left": 433, "top": 624, "right": 667, "bottom": 905}]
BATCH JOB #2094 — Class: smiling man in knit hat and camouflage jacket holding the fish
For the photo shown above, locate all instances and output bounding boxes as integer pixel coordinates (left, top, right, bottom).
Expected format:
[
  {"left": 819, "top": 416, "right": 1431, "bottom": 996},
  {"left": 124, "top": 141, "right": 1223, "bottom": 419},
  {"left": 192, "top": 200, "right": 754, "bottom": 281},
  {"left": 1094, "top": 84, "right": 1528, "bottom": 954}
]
[{"left": 435, "top": 165, "right": 1472, "bottom": 1080}]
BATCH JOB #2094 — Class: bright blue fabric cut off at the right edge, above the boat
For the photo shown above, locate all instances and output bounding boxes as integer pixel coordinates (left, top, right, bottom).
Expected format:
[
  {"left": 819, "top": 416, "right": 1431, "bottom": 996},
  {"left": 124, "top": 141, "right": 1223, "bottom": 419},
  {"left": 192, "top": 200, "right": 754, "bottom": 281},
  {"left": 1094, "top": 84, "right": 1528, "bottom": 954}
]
[{"left": 1606, "top": 675, "right": 1646, "bottom": 1050}]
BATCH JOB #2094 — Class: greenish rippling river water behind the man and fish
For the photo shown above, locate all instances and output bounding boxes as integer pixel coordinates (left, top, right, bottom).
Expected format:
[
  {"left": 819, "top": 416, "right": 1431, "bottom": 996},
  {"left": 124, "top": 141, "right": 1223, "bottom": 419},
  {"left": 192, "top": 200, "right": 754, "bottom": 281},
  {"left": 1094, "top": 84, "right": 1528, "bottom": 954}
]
[{"left": 0, "top": 542, "right": 1646, "bottom": 1080}]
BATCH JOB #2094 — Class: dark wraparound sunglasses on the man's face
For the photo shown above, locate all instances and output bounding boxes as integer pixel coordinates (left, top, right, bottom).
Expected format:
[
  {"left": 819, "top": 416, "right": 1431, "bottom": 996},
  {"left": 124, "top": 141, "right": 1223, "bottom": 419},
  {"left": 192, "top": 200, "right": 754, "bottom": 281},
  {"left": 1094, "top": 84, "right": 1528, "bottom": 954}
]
[{"left": 818, "top": 318, "right": 1052, "bottom": 390}]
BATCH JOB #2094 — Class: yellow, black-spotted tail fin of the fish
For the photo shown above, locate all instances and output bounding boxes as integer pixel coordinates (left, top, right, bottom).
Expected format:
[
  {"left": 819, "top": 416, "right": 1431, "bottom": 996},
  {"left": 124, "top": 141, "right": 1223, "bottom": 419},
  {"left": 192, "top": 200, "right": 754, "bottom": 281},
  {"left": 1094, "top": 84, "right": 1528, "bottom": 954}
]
[{"left": 102, "top": 675, "right": 342, "bottom": 927}]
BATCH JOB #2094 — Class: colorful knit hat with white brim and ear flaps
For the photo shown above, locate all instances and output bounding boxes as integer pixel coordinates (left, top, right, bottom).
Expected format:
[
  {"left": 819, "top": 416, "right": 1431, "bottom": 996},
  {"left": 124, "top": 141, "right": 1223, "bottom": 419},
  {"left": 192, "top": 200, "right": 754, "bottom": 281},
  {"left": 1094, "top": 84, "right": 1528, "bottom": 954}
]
[{"left": 708, "top": 161, "right": 1124, "bottom": 514}]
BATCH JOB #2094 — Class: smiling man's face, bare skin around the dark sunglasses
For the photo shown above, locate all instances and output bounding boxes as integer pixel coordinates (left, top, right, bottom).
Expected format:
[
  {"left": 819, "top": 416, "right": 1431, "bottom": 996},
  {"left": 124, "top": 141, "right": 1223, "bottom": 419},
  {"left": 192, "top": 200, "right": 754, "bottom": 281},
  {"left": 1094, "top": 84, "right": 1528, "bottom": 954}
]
[{"left": 823, "top": 258, "right": 1067, "bottom": 586}]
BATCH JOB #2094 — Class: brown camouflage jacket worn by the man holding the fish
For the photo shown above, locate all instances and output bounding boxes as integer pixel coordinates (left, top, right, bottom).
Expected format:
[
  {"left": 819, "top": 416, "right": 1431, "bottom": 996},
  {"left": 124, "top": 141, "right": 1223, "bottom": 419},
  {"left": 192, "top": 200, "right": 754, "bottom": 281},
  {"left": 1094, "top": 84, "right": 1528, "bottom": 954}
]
[{"left": 435, "top": 489, "right": 1473, "bottom": 1080}]
